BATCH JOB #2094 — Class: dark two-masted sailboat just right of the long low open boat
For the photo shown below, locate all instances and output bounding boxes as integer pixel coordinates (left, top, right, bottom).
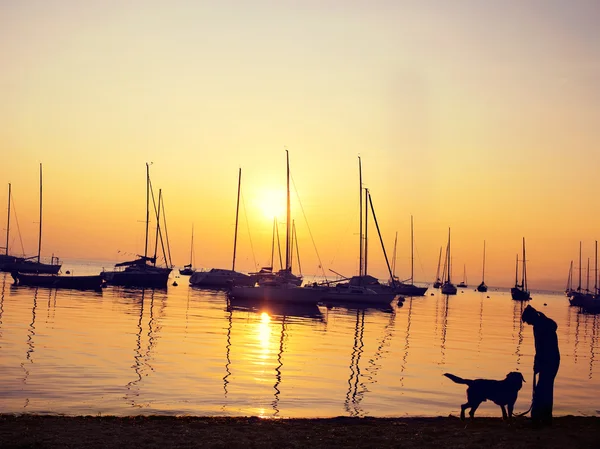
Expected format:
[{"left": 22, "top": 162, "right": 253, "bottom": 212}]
[{"left": 102, "top": 163, "right": 172, "bottom": 288}]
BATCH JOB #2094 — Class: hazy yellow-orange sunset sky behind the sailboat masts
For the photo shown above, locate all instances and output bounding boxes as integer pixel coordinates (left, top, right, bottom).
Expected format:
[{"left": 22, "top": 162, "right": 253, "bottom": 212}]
[{"left": 0, "top": 0, "right": 600, "bottom": 289}]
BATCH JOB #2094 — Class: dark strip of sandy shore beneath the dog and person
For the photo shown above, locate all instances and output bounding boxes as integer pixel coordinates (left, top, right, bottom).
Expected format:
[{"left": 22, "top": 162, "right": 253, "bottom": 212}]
[{"left": 0, "top": 415, "right": 600, "bottom": 449}]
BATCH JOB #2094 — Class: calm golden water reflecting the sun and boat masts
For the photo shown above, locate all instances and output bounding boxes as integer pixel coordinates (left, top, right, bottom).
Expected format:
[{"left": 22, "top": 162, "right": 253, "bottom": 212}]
[{"left": 0, "top": 265, "right": 600, "bottom": 417}]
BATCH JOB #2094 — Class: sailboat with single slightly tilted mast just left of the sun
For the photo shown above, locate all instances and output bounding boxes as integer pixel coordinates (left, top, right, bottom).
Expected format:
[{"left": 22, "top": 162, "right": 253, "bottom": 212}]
[{"left": 190, "top": 168, "right": 256, "bottom": 289}]
